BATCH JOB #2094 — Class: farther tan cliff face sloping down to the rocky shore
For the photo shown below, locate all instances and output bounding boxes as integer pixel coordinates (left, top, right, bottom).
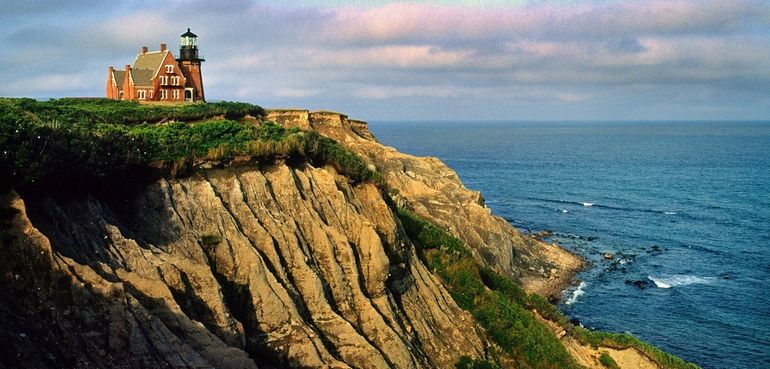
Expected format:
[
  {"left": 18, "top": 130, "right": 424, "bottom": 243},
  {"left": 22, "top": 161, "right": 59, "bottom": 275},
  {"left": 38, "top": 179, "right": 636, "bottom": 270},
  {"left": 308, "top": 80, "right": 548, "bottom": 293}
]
[{"left": 267, "top": 109, "right": 583, "bottom": 297}]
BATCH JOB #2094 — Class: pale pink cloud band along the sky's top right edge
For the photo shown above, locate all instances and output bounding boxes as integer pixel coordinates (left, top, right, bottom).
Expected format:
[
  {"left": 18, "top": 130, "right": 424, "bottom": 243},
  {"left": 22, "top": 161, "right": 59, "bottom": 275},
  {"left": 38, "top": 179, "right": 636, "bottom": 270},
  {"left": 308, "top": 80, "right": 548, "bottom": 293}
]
[{"left": 320, "top": 0, "right": 770, "bottom": 43}]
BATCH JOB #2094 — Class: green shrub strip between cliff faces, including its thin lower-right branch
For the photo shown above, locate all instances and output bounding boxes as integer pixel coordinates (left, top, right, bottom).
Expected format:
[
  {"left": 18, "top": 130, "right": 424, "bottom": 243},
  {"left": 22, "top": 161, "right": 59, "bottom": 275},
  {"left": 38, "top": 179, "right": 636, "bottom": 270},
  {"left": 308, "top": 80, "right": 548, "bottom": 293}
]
[{"left": 398, "top": 209, "right": 698, "bottom": 369}]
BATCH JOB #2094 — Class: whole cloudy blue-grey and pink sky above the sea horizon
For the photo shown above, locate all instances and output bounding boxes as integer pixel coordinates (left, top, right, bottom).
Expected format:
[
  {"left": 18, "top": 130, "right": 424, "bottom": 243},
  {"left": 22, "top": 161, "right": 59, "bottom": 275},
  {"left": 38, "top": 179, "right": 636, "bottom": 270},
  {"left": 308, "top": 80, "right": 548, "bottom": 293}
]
[{"left": 0, "top": 0, "right": 770, "bottom": 121}]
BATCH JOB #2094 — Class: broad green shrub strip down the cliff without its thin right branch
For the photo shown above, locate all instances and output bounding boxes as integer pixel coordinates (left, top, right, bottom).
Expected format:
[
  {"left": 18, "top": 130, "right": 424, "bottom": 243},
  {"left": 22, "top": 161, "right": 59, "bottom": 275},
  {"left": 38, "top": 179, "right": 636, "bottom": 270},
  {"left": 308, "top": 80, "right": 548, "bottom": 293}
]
[{"left": 398, "top": 209, "right": 580, "bottom": 369}]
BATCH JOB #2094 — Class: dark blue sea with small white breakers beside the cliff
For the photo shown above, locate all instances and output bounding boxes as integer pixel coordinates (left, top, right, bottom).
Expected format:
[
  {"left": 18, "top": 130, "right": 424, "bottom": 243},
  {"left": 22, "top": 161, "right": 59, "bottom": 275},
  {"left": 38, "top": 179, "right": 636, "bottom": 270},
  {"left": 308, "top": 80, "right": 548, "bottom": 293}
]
[{"left": 370, "top": 122, "right": 770, "bottom": 369}]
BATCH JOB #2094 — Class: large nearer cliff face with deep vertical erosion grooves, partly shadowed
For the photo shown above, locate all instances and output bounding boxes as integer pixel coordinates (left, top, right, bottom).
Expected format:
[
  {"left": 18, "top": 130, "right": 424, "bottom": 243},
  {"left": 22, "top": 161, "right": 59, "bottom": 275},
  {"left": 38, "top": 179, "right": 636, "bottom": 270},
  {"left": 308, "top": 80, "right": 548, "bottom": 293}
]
[{"left": 0, "top": 164, "right": 488, "bottom": 368}]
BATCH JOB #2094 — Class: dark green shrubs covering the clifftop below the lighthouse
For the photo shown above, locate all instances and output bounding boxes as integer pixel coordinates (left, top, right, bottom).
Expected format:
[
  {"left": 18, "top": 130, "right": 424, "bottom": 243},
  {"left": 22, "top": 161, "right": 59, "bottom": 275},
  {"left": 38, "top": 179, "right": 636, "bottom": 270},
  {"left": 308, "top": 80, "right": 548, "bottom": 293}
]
[{"left": 0, "top": 98, "right": 381, "bottom": 189}]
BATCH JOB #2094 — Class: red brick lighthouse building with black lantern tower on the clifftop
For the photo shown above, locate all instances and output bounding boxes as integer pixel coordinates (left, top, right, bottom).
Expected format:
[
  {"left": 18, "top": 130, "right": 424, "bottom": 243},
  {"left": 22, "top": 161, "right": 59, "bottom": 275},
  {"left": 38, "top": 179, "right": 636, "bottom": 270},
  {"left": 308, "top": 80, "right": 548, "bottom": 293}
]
[{"left": 107, "top": 28, "right": 205, "bottom": 102}]
